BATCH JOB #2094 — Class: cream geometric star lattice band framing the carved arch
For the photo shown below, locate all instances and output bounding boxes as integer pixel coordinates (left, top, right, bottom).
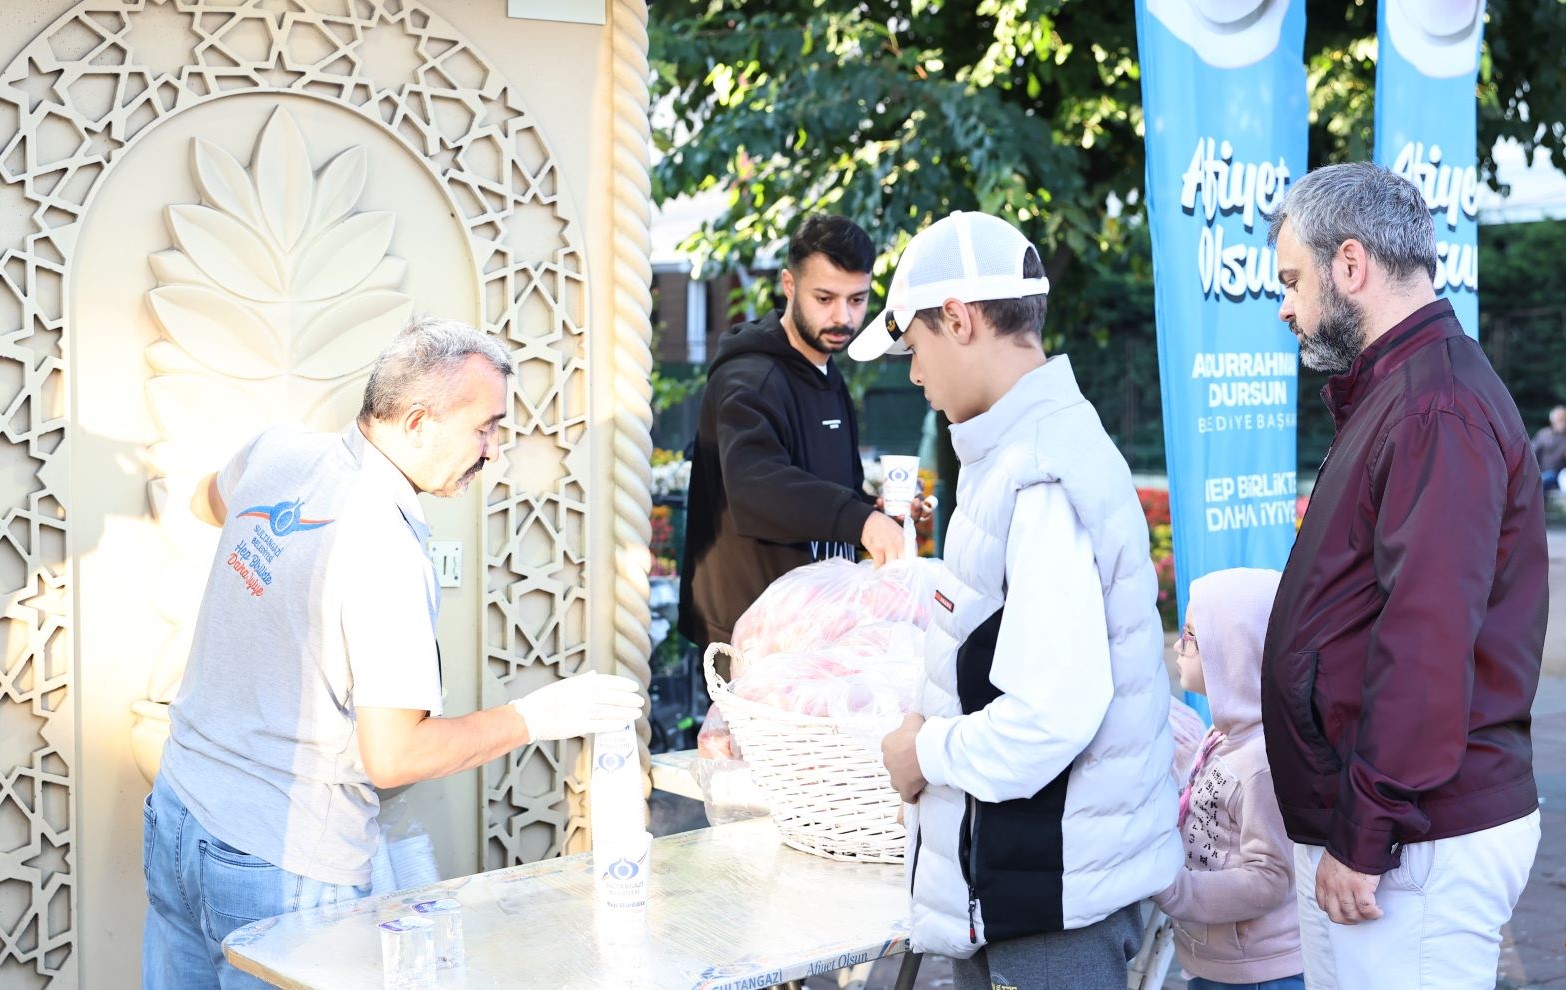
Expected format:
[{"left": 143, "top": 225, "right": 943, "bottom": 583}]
[{"left": 0, "top": 0, "right": 610, "bottom": 987}]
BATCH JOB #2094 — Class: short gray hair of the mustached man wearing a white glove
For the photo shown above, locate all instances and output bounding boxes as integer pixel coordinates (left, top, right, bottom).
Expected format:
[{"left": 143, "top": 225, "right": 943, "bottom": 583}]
[{"left": 359, "top": 315, "right": 512, "bottom": 423}]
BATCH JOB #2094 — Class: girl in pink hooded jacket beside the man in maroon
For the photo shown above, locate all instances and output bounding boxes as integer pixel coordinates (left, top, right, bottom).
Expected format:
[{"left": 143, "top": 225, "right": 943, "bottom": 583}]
[{"left": 1154, "top": 569, "right": 1304, "bottom": 990}]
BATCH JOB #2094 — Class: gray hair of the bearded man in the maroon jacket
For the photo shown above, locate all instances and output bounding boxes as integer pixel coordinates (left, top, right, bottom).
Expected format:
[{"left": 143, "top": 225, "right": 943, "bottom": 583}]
[{"left": 1267, "top": 161, "right": 1436, "bottom": 282}]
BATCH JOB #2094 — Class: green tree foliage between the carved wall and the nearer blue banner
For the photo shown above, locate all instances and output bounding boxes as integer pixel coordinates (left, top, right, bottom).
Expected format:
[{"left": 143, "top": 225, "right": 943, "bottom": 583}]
[{"left": 651, "top": 0, "right": 1142, "bottom": 307}]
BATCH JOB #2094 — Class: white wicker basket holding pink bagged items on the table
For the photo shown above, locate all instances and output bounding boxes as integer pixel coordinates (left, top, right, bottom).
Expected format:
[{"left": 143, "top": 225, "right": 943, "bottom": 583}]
[{"left": 702, "top": 642, "right": 907, "bottom": 863}]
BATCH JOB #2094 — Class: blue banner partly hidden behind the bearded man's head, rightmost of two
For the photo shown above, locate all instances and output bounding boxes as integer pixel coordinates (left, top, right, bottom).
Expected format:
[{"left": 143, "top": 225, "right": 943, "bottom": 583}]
[{"left": 1375, "top": 0, "right": 1485, "bottom": 338}]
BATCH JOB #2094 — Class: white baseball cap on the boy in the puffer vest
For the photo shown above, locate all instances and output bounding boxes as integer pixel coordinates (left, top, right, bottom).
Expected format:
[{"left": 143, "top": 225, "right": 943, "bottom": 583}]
[{"left": 849, "top": 211, "right": 1049, "bottom": 360}]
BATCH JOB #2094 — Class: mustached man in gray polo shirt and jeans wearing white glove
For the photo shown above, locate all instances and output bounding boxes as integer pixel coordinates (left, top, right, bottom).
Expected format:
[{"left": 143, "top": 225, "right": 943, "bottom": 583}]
[{"left": 143, "top": 318, "right": 642, "bottom": 990}]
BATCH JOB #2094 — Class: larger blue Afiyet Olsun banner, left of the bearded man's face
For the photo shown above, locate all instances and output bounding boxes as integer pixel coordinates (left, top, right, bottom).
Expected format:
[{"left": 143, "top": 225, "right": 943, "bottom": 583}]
[{"left": 1137, "top": 0, "right": 1308, "bottom": 714}]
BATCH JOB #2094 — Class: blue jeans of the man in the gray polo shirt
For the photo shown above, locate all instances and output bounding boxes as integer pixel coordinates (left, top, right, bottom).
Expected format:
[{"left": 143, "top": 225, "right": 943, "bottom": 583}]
[{"left": 141, "top": 777, "right": 370, "bottom": 990}]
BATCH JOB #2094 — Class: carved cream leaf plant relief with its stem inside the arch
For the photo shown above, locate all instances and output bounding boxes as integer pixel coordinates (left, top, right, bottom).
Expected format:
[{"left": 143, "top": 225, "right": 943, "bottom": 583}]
[{"left": 146, "top": 108, "right": 413, "bottom": 700}]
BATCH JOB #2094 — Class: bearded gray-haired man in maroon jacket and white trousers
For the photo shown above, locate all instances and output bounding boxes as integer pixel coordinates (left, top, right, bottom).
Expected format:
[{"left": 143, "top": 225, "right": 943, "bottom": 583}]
[{"left": 1262, "top": 163, "right": 1549, "bottom": 990}]
